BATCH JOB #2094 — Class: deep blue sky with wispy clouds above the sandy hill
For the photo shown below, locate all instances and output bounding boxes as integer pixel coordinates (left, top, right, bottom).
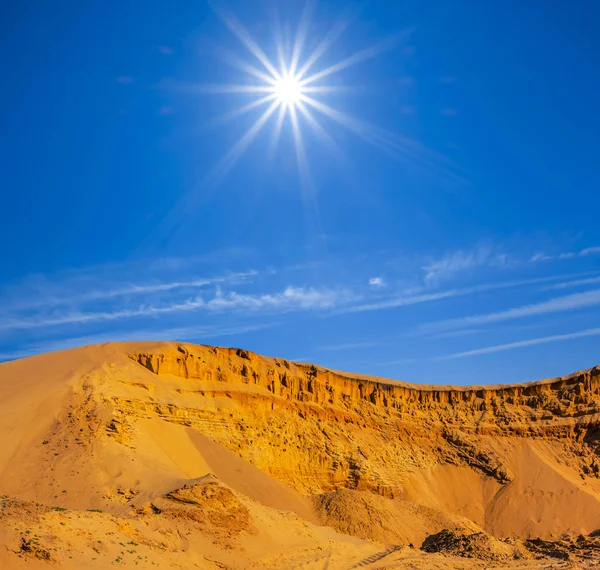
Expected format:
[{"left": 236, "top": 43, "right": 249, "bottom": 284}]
[{"left": 0, "top": 0, "right": 600, "bottom": 384}]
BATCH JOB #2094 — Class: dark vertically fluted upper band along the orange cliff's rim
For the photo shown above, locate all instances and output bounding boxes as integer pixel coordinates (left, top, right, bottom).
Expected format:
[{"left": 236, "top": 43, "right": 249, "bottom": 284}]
[{"left": 129, "top": 345, "right": 600, "bottom": 431}]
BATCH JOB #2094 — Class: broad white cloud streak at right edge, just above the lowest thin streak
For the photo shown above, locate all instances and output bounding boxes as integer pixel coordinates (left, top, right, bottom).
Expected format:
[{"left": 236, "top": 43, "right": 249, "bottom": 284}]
[{"left": 420, "top": 289, "right": 600, "bottom": 331}]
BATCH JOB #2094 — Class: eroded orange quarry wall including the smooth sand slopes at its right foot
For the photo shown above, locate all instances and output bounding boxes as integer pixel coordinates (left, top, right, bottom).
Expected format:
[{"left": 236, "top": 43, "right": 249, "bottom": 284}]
[{"left": 118, "top": 345, "right": 600, "bottom": 536}]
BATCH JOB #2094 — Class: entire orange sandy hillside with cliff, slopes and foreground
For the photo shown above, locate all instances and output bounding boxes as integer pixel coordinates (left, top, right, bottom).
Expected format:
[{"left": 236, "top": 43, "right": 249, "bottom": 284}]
[{"left": 0, "top": 343, "right": 600, "bottom": 569}]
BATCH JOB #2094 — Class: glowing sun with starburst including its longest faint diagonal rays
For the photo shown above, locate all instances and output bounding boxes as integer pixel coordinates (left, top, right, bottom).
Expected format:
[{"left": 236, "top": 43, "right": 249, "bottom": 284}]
[{"left": 151, "top": 4, "right": 463, "bottom": 247}]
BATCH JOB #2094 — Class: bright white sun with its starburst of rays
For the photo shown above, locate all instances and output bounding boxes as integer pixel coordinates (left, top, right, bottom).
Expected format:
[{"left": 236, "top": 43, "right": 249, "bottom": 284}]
[{"left": 180, "top": 0, "right": 414, "bottom": 204}]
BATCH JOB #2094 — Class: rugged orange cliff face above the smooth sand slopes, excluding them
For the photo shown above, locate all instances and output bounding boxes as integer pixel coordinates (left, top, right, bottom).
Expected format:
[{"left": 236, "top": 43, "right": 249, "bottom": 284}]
[{"left": 117, "top": 345, "right": 600, "bottom": 506}]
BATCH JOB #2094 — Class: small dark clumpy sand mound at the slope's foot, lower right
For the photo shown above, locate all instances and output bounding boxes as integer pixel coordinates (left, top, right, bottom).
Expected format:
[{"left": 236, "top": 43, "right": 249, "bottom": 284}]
[{"left": 421, "top": 529, "right": 522, "bottom": 562}]
